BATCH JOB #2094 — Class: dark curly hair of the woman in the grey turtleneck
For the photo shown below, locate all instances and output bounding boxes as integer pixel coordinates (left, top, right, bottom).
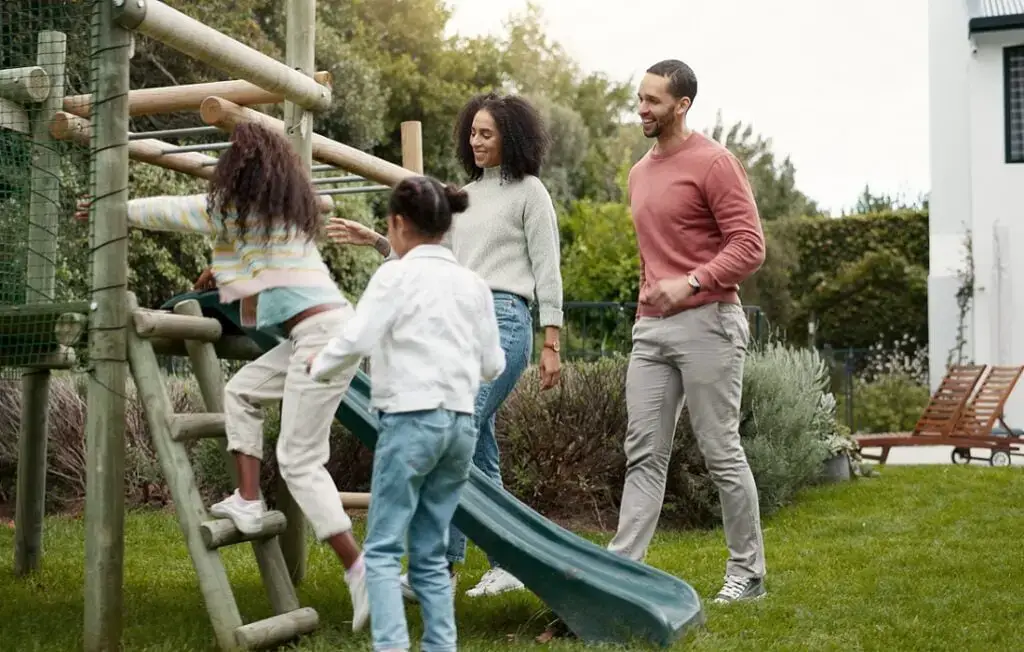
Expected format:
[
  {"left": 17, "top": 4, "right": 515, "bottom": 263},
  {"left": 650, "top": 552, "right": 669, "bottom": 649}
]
[{"left": 455, "top": 92, "right": 551, "bottom": 181}]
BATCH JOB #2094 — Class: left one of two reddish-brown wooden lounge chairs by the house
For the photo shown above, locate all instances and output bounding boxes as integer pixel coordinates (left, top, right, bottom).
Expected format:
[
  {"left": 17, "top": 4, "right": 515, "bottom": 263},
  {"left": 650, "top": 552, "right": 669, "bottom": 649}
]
[{"left": 853, "top": 364, "right": 987, "bottom": 464}]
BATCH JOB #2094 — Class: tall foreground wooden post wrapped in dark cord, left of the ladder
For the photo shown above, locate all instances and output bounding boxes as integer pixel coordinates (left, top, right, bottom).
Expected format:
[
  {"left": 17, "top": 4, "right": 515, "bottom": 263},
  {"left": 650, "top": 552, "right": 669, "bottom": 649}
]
[{"left": 83, "top": 2, "right": 131, "bottom": 652}]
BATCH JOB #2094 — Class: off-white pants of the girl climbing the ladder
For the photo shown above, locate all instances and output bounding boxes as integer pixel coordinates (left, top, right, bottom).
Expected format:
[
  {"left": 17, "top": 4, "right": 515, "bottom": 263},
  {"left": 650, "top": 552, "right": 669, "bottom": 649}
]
[{"left": 224, "top": 306, "right": 355, "bottom": 540}]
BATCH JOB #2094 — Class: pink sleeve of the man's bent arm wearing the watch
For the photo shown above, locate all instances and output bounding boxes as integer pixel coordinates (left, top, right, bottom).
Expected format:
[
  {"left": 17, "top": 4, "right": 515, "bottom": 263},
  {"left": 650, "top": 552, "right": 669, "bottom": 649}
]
[{"left": 693, "top": 154, "right": 765, "bottom": 288}]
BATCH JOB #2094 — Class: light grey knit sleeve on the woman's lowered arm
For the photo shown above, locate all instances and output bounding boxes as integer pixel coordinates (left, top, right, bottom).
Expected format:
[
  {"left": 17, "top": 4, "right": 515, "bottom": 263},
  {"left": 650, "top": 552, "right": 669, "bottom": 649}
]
[{"left": 523, "top": 178, "right": 562, "bottom": 328}]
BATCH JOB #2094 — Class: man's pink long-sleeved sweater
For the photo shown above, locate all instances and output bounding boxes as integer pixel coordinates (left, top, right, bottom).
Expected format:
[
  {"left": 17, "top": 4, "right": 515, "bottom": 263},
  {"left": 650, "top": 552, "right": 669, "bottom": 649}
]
[{"left": 629, "top": 132, "right": 765, "bottom": 317}]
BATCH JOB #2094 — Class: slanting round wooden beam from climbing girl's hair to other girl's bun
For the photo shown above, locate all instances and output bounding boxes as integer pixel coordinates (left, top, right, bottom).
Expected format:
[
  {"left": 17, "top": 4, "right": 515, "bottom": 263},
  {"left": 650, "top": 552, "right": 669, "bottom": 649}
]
[{"left": 199, "top": 97, "right": 416, "bottom": 186}]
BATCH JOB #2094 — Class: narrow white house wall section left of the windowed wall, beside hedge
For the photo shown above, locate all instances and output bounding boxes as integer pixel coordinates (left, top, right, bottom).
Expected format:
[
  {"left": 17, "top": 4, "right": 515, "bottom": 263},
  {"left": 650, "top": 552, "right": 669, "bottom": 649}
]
[{"left": 928, "top": 1, "right": 972, "bottom": 391}]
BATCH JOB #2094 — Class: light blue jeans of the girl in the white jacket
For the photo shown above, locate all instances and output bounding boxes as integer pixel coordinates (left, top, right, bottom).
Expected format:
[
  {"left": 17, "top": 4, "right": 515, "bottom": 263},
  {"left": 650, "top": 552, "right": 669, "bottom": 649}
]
[{"left": 362, "top": 409, "right": 476, "bottom": 652}]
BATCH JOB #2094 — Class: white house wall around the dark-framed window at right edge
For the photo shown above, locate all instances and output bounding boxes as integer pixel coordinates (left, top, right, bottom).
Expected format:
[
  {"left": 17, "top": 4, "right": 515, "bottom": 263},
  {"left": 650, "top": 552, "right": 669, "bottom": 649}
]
[{"left": 966, "top": 31, "right": 1024, "bottom": 426}]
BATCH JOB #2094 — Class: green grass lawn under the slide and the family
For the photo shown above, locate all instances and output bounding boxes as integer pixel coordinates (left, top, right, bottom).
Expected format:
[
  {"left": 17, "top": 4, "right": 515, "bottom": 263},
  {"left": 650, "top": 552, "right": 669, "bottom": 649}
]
[{"left": 0, "top": 466, "right": 1024, "bottom": 652}]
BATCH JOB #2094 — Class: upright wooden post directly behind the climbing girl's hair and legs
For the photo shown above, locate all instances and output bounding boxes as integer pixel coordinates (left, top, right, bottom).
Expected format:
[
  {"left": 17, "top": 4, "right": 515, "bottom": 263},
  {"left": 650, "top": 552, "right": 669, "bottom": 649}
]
[{"left": 276, "top": 0, "right": 316, "bottom": 586}]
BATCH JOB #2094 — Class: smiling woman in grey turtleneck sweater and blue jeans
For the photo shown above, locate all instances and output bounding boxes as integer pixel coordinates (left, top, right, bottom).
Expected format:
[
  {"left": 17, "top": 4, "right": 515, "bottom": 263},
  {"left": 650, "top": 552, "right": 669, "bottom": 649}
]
[{"left": 328, "top": 93, "right": 562, "bottom": 600}]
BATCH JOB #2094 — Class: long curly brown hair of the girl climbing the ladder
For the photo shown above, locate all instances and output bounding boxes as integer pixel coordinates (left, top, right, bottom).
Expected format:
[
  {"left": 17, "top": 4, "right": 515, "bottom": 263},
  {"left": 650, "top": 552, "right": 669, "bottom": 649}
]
[{"left": 207, "top": 123, "right": 321, "bottom": 243}]
